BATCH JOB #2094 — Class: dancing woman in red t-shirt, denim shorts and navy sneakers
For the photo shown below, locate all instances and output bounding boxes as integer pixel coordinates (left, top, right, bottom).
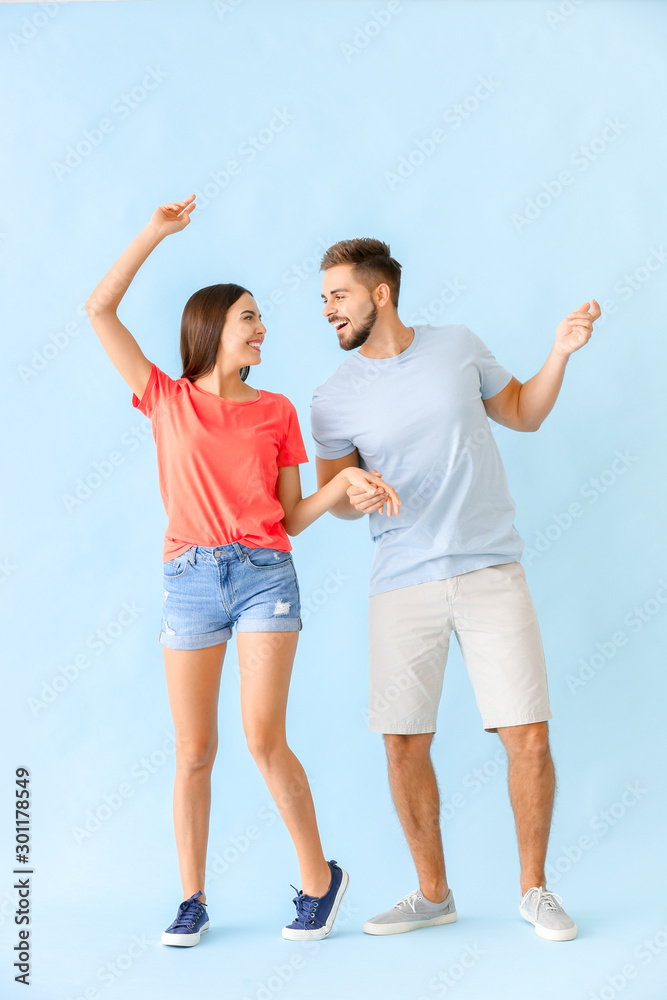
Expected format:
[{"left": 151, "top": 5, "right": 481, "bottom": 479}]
[{"left": 86, "top": 195, "right": 400, "bottom": 946}]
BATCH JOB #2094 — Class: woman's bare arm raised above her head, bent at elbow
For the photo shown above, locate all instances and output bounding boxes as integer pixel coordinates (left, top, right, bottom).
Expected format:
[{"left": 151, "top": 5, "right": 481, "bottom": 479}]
[{"left": 86, "top": 195, "right": 195, "bottom": 399}]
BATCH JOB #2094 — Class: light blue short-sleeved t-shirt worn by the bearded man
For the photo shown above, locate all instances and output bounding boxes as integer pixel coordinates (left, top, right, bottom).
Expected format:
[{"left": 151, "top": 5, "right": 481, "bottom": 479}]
[{"left": 311, "top": 325, "right": 524, "bottom": 595}]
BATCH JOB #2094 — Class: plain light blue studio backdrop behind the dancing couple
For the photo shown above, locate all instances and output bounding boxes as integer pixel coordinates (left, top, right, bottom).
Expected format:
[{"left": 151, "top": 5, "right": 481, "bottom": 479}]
[{"left": 0, "top": 0, "right": 667, "bottom": 1000}]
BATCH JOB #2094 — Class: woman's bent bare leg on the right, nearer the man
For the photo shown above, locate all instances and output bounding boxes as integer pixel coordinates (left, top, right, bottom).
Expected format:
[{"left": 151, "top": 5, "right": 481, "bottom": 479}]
[{"left": 237, "top": 632, "right": 331, "bottom": 896}]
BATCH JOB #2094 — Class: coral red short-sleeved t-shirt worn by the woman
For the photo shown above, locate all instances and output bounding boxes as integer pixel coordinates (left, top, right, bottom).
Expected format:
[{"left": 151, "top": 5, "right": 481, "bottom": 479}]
[{"left": 132, "top": 364, "right": 308, "bottom": 562}]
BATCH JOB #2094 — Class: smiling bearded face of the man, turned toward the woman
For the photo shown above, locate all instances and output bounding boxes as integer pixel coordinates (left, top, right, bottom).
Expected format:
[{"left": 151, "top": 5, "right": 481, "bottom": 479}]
[{"left": 322, "top": 264, "right": 378, "bottom": 351}]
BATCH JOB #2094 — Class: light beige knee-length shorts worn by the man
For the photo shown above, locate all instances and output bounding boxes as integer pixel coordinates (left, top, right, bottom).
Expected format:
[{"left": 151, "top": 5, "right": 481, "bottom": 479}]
[{"left": 368, "top": 562, "right": 551, "bottom": 733}]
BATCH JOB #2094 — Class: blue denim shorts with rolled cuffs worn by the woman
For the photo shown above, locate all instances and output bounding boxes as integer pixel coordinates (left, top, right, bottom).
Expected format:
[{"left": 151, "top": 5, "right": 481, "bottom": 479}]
[{"left": 159, "top": 542, "right": 302, "bottom": 649}]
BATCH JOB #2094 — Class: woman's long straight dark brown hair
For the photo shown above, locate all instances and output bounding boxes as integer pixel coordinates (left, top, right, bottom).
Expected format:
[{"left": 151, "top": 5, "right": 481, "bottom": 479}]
[{"left": 181, "top": 284, "right": 252, "bottom": 382}]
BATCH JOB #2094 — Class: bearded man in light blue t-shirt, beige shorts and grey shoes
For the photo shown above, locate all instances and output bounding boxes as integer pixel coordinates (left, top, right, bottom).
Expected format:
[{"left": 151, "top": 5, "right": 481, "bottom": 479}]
[{"left": 311, "top": 239, "right": 600, "bottom": 941}]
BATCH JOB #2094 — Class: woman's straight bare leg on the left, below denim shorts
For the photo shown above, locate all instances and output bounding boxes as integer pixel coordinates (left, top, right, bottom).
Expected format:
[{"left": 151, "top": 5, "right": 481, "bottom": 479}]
[{"left": 163, "top": 642, "right": 227, "bottom": 902}]
